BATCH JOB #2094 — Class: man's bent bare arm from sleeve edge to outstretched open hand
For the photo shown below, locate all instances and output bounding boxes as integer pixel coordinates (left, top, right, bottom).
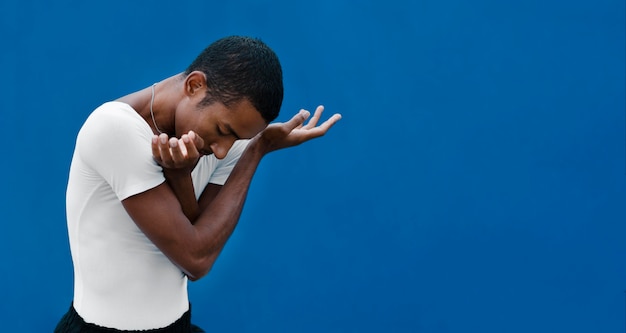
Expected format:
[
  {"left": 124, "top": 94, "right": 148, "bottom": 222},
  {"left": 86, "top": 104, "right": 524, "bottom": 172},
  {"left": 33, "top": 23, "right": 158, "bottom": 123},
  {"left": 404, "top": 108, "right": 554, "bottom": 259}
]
[{"left": 122, "top": 107, "right": 340, "bottom": 280}]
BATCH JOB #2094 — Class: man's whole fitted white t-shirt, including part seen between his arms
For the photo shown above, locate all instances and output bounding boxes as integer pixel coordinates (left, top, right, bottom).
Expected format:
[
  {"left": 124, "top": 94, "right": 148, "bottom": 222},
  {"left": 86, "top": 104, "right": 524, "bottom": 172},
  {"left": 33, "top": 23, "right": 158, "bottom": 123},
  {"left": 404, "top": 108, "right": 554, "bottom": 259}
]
[{"left": 67, "top": 102, "right": 247, "bottom": 330}]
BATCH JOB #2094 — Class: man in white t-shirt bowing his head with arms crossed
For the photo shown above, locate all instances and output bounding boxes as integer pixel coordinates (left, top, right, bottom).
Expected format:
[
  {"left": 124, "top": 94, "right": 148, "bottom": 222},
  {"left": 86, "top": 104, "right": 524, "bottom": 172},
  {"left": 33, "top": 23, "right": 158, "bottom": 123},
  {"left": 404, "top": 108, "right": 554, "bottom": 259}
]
[{"left": 56, "top": 36, "right": 341, "bottom": 332}]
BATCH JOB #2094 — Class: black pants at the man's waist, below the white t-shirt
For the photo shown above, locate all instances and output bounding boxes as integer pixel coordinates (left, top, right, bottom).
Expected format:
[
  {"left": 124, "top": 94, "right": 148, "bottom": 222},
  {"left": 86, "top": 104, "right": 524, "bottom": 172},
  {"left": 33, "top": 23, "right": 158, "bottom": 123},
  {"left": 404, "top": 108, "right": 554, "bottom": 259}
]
[{"left": 54, "top": 304, "right": 204, "bottom": 333}]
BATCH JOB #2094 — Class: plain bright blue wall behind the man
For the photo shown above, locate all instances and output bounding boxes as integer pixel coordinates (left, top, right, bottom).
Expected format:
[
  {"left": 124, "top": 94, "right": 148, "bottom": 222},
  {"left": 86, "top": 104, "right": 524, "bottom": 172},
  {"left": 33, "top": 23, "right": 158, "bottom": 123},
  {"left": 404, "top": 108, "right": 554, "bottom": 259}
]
[{"left": 0, "top": 0, "right": 626, "bottom": 333}]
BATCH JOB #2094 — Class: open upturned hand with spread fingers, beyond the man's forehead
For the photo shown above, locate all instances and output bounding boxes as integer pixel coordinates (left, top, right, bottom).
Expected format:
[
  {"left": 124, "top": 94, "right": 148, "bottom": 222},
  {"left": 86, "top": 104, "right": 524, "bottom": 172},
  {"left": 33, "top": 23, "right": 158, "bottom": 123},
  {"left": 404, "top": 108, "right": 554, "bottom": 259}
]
[{"left": 253, "top": 105, "right": 341, "bottom": 153}]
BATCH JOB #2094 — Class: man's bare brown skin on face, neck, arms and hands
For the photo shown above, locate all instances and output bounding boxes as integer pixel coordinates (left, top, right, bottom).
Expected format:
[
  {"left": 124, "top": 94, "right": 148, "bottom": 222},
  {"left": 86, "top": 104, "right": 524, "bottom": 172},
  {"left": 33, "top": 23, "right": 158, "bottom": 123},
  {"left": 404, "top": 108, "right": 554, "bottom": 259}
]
[{"left": 119, "top": 72, "right": 341, "bottom": 280}]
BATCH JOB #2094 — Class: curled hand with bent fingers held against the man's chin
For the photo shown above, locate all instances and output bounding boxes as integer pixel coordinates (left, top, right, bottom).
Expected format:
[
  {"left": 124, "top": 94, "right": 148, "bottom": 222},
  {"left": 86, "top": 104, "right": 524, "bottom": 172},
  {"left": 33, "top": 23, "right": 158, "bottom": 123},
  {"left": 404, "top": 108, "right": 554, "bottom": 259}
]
[{"left": 152, "top": 131, "right": 204, "bottom": 172}]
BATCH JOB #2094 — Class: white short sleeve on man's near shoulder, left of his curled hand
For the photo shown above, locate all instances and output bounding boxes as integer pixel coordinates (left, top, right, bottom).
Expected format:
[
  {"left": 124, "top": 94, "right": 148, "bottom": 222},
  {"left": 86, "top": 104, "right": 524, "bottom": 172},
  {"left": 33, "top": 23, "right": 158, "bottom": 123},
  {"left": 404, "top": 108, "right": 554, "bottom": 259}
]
[{"left": 76, "top": 103, "right": 165, "bottom": 201}]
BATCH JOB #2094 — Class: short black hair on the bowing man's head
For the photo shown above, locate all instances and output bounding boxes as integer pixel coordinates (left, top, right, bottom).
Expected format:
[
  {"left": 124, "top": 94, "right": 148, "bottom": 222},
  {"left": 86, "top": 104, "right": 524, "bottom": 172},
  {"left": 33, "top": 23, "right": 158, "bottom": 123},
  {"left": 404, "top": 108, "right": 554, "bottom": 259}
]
[{"left": 185, "top": 36, "right": 283, "bottom": 123}]
